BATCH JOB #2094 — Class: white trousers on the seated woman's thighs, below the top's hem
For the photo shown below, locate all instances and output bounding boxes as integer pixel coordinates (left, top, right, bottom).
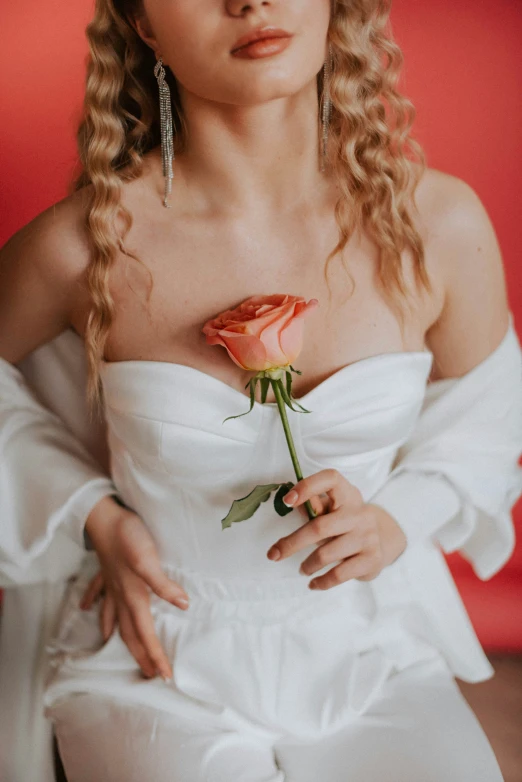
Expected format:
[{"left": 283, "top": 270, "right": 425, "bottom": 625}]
[{"left": 48, "top": 657, "right": 503, "bottom": 782}]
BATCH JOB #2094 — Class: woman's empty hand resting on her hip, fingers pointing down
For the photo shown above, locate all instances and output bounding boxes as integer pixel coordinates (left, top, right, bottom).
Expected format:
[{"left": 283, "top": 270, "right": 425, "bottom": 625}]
[{"left": 80, "top": 497, "right": 188, "bottom": 679}]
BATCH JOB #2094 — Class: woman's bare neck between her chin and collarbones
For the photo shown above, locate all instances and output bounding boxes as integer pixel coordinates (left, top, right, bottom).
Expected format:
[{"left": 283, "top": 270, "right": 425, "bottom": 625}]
[{"left": 165, "top": 80, "right": 324, "bottom": 213}]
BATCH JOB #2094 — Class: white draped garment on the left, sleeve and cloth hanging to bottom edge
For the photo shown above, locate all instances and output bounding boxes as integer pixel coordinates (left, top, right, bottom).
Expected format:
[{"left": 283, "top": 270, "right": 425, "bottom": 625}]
[{"left": 0, "top": 330, "right": 116, "bottom": 782}]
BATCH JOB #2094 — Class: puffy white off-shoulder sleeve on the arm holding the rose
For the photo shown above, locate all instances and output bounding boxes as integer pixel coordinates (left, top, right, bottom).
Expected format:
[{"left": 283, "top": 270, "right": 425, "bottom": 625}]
[{"left": 369, "top": 313, "right": 522, "bottom": 580}]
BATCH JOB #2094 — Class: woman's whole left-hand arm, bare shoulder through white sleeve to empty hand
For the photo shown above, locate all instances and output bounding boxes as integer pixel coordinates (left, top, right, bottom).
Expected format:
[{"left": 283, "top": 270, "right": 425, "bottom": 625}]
[{"left": 0, "top": 207, "right": 188, "bottom": 677}]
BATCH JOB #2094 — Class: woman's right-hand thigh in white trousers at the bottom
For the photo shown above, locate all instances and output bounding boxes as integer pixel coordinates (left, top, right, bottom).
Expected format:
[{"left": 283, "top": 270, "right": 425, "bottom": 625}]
[{"left": 276, "top": 660, "right": 503, "bottom": 782}]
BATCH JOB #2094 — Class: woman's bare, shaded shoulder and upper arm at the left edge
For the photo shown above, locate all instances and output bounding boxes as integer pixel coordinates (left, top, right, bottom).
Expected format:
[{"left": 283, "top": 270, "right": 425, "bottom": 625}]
[{"left": 0, "top": 191, "right": 90, "bottom": 363}]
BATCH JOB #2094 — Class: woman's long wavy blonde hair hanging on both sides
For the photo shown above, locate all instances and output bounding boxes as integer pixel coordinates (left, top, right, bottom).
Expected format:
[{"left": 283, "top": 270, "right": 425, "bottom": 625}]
[{"left": 70, "top": 0, "right": 431, "bottom": 422}]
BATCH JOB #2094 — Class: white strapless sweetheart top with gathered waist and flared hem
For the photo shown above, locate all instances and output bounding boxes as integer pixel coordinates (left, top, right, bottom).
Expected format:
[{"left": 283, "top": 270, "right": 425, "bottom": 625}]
[{"left": 41, "top": 351, "right": 476, "bottom": 738}]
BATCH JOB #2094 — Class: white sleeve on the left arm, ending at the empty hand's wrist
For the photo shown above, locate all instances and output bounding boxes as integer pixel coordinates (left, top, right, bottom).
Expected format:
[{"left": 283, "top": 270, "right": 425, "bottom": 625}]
[{"left": 0, "top": 358, "right": 117, "bottom": 587}]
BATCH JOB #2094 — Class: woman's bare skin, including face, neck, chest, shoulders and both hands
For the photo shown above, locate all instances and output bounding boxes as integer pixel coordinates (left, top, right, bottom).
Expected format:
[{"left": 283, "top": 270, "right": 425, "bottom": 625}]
[{"left": 0, "top": 0, "right": 509, "bottom": 678}]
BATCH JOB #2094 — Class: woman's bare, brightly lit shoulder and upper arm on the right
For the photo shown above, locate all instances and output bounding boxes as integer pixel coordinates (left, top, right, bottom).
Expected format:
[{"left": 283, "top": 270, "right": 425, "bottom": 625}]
[{"left": 406, "top": 168, "right": 509, "bottom": 379}]
